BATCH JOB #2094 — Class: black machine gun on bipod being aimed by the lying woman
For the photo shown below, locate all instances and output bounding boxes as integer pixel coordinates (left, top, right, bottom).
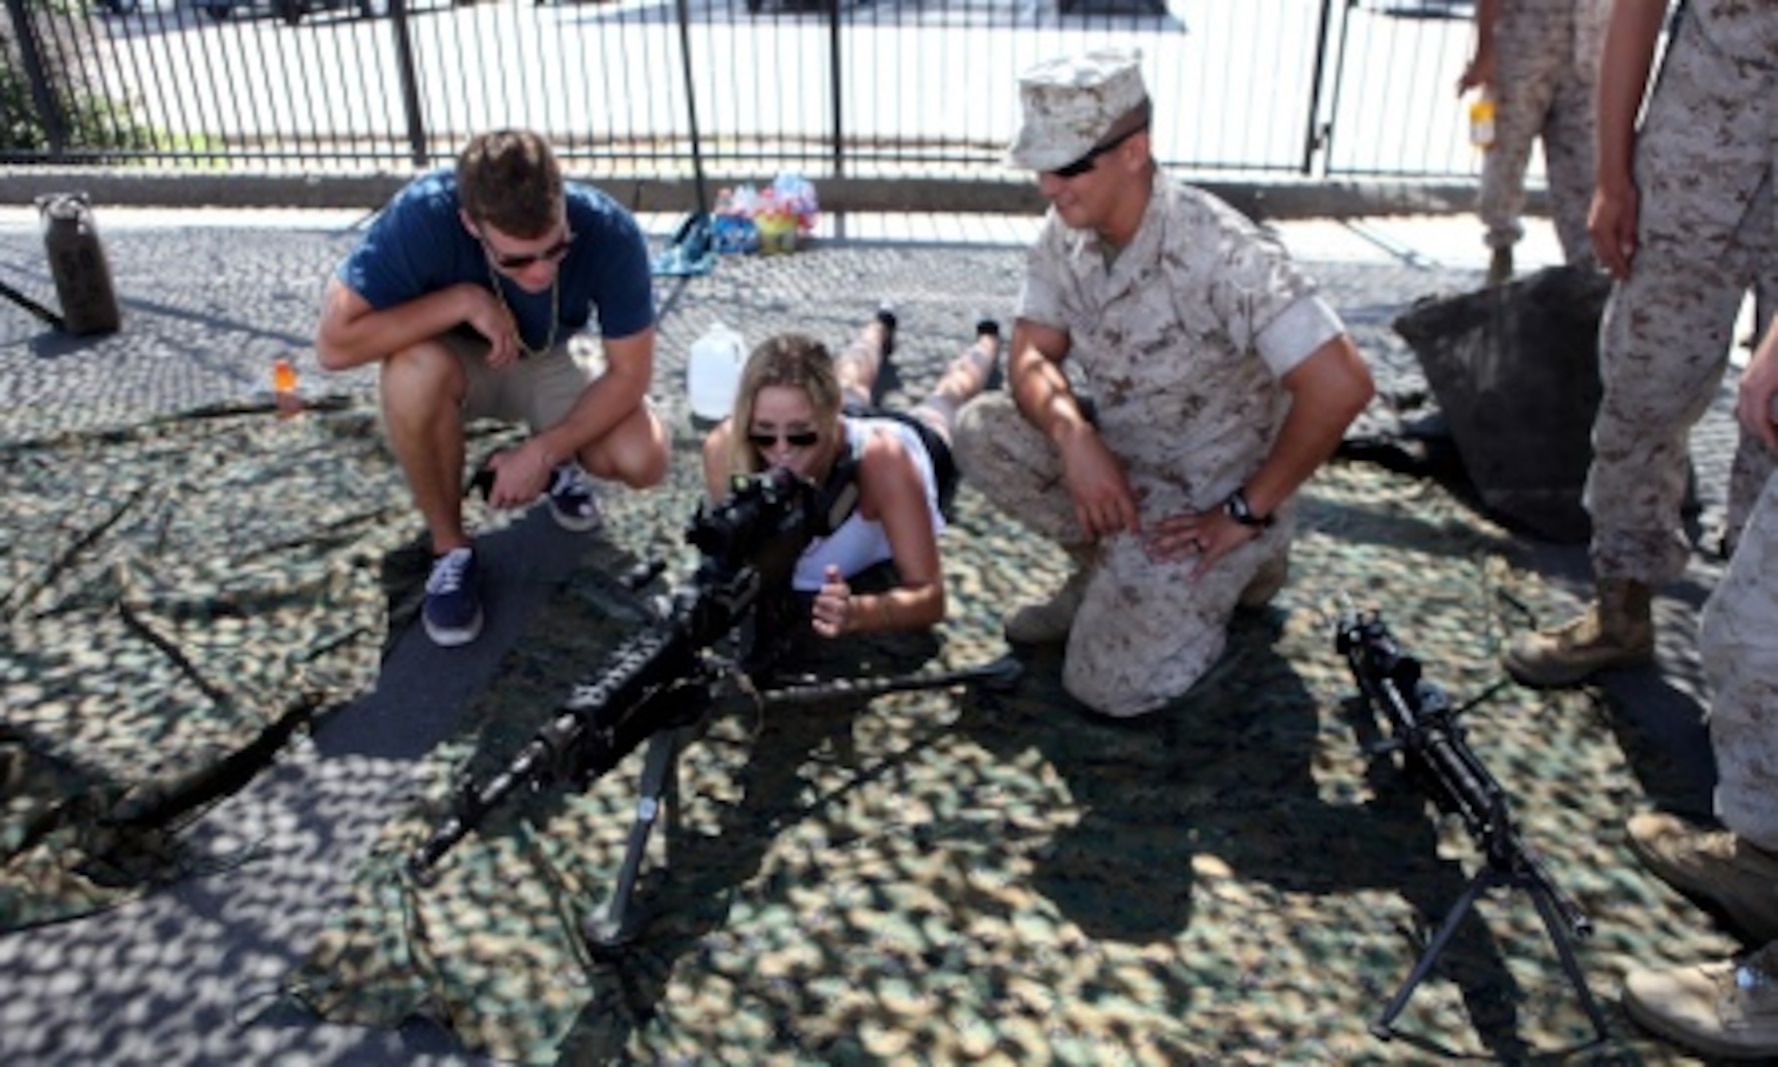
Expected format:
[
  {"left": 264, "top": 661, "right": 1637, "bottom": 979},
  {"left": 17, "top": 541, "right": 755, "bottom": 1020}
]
[{"left": 407, "top": 468, "right": 1015, "bottom": 948}]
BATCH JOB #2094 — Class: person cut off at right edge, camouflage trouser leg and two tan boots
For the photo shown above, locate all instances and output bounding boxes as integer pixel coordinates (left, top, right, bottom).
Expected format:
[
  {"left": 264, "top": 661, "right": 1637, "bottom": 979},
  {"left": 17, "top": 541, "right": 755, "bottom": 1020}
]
[{"left": 1623, "top": 312, "right": 1778, "bottom": 1058}]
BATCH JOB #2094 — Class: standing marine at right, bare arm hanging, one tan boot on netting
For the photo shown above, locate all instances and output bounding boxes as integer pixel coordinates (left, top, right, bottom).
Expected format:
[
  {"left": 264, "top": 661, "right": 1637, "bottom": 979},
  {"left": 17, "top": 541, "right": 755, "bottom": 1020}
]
[{"left": 1504, "top": 0, "right": 1778, "bottom": 686}]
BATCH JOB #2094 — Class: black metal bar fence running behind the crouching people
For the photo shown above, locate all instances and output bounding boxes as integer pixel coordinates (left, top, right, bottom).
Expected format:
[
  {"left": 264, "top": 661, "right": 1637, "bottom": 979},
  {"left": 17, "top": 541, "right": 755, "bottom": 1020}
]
[{"left": 0, "top": 0, "right": 1507, "bottom": 201}]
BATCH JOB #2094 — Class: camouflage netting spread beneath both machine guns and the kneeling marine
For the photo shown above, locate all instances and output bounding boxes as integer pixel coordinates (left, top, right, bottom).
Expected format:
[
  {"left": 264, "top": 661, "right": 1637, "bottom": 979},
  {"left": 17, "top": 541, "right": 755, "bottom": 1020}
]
[{"left": 288, "top": 453, "right": 1728, "bottom": 1063}]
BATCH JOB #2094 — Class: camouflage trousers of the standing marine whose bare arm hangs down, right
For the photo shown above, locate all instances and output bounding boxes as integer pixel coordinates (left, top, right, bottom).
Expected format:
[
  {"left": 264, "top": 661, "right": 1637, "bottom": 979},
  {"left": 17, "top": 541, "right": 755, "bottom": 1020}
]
[{"left": 1586, "top": 0, "right": 1778, "bottom": 587}]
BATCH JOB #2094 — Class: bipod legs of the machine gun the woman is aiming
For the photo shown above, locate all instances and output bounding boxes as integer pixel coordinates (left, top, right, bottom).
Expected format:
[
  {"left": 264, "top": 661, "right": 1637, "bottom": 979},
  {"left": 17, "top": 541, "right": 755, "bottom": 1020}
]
[{"left": 580, "top": 656, "right": 1022, "bottom": 957}]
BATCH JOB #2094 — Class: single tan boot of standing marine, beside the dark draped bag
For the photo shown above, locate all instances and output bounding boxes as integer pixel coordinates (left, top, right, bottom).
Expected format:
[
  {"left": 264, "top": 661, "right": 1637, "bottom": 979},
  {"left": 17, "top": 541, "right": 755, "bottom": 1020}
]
[{"left": 1501, "top": 578, "right": 1655, "bottom": 688}]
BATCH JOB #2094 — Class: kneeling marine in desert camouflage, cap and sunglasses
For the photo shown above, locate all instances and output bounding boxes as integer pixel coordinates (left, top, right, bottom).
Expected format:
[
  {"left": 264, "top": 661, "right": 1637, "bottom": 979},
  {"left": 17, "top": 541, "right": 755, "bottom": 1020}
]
[{"left": 955, "top": 52, "right": 1373, "bottom": 717}]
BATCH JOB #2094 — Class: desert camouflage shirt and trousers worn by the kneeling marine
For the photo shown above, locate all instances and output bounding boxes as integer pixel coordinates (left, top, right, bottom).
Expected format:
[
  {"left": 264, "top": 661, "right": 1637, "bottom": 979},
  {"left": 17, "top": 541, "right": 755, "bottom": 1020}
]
[{"left": 957, "top": 172, "right": 1342, "bottom": 715}]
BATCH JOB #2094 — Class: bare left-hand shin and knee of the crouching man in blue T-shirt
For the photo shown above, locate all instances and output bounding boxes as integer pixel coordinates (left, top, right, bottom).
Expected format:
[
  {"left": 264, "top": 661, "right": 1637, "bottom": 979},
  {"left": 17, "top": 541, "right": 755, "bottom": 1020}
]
[{"left": 380, "top": 341, "right": 469, "bottom": 555}]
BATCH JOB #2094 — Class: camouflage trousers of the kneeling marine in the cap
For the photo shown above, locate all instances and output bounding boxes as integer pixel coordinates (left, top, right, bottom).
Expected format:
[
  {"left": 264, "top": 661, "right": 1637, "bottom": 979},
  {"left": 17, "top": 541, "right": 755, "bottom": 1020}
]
[{"left": 955, "top": 393, "right": 1293, "bottom": 717}]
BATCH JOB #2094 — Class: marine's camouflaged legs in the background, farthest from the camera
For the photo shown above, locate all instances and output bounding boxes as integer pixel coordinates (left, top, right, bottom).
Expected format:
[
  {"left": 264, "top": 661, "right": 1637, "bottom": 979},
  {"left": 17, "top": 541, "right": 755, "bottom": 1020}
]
[{"left": 1456, "top": 0, "right": 1611, "bottom": 285}]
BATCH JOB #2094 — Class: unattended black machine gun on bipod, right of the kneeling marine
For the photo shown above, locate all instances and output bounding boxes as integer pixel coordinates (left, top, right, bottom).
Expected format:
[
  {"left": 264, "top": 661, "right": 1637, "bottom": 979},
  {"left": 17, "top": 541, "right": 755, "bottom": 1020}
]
[{"left": 1335, "top": 610, "right": 1606, "bottom": 1040}]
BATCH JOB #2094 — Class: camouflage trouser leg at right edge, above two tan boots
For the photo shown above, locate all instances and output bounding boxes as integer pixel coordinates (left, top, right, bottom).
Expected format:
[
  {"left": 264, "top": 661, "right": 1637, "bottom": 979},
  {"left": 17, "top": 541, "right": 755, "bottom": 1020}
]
[{"left": 1698, "top": 478, "right": 1778, "bottom": 852}]
